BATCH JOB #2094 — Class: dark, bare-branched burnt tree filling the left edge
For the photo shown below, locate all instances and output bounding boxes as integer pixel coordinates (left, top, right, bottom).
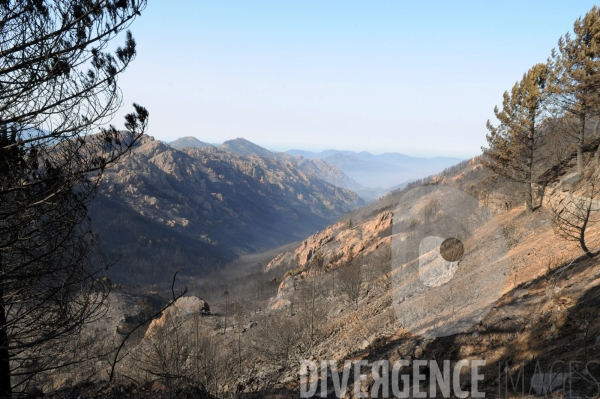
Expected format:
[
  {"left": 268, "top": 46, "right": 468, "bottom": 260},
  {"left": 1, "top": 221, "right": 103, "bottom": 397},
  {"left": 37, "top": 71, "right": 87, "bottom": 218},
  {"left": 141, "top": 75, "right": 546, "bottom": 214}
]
[{"left": 0, "top": 0, "right": 148, "bottom": 397}]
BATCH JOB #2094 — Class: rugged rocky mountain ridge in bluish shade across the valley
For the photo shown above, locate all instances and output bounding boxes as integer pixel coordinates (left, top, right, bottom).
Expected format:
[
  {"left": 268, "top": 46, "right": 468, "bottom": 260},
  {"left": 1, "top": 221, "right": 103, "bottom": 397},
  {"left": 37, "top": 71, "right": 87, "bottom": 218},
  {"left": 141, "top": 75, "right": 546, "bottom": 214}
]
[{"left": 91, "top": 137, "right": 362, "bottom": 282}]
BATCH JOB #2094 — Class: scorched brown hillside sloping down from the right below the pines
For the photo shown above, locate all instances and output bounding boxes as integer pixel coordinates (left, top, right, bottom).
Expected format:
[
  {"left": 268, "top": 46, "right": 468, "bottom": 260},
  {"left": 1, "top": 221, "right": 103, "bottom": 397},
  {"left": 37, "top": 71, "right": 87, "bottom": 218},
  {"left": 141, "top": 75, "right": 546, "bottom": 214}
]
[{"left": 54, "top": 141, "right": 600, "bottom": 399}]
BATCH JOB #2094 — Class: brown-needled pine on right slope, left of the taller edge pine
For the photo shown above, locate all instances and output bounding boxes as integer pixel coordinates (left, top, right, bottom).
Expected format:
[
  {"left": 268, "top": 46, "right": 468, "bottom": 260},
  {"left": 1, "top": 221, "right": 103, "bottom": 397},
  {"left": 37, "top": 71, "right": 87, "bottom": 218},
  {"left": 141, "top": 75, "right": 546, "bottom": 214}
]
[{"left": 482, "top": 64, "right": 549, "bottom": 212}]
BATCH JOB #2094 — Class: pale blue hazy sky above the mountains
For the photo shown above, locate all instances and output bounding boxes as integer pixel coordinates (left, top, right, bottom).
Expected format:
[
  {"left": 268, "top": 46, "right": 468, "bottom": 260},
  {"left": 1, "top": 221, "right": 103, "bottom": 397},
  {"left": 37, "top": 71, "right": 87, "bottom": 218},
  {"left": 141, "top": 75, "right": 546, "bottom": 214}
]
[{"left": 110, "top": 0, "right": 594, "bottom": 157}]
